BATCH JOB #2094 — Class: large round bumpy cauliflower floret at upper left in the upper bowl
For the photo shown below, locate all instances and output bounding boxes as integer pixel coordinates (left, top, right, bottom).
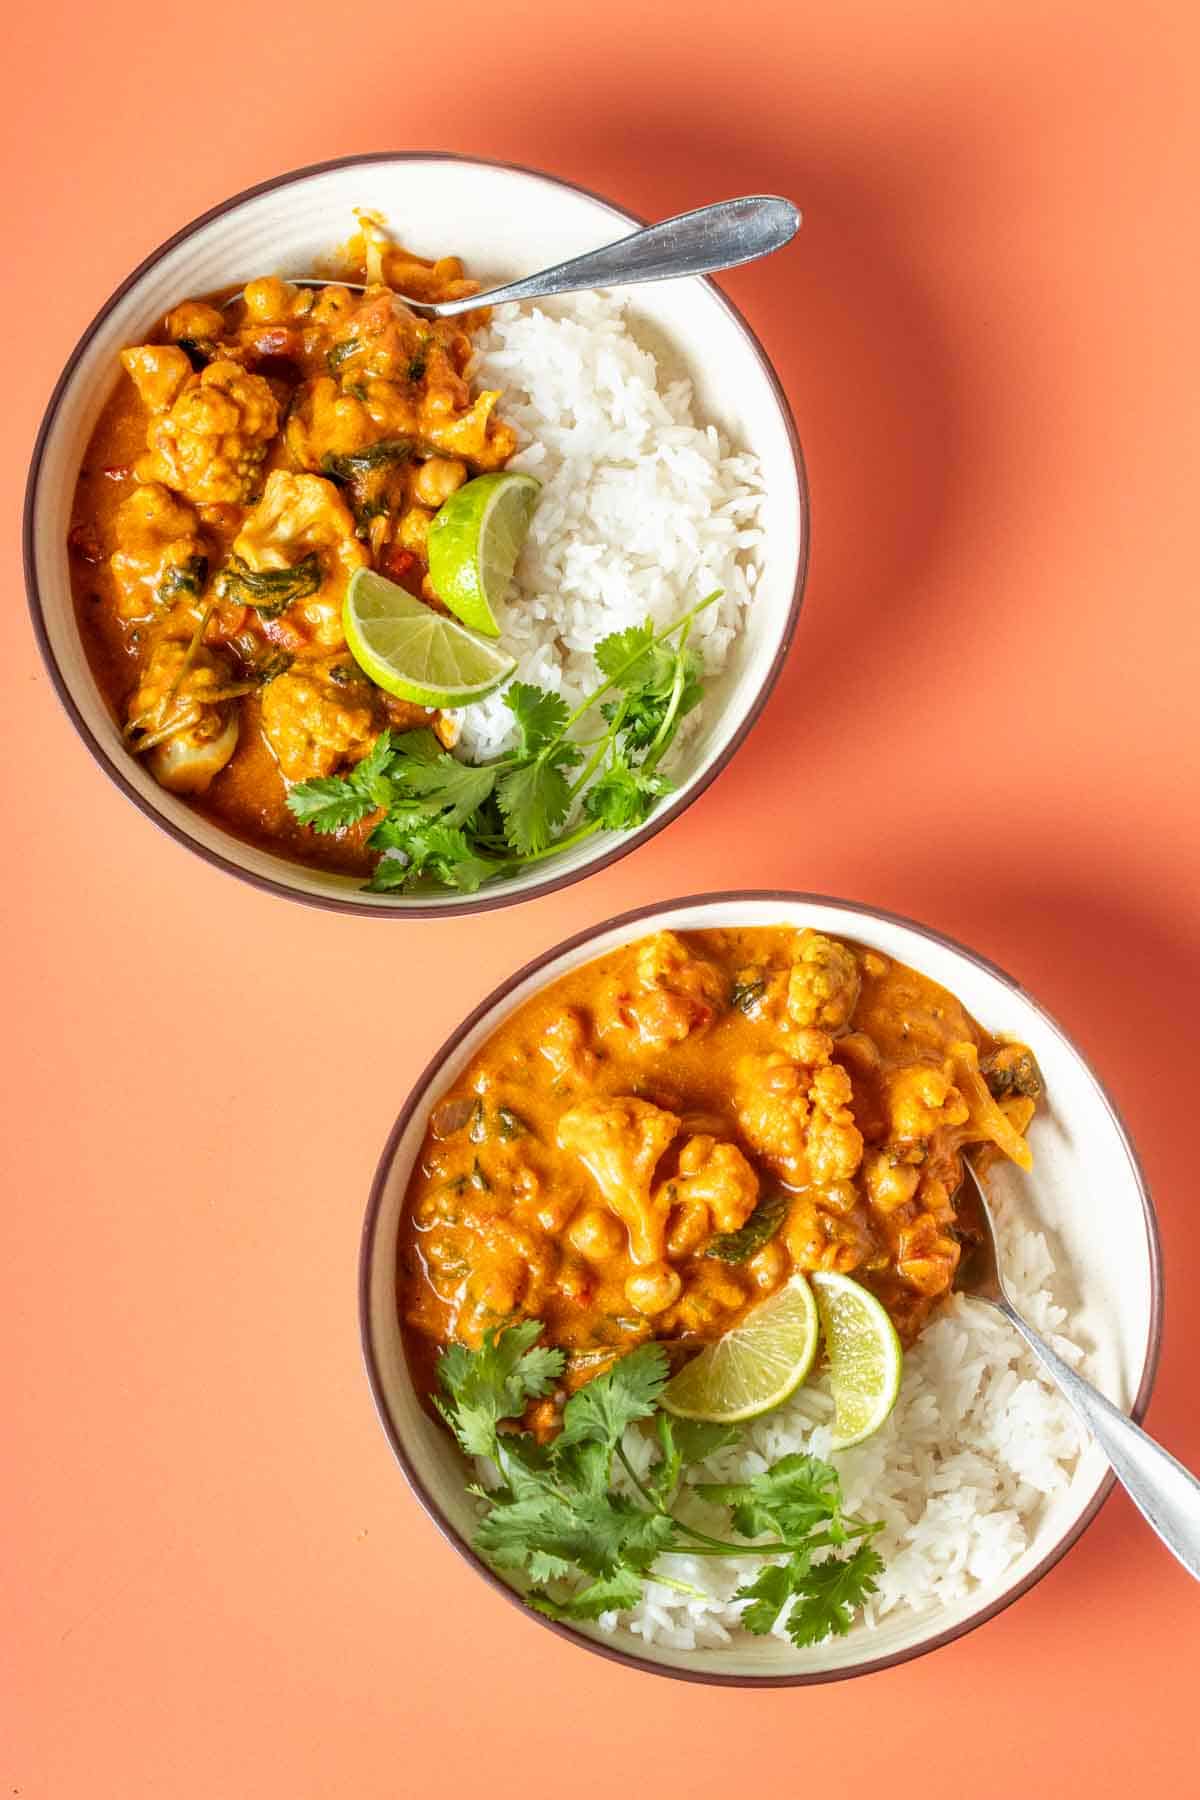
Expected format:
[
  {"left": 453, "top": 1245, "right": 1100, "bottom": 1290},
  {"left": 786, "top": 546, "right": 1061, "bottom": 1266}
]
[{"left": 137, "top": 349, "right": 279, "bottom": 506}]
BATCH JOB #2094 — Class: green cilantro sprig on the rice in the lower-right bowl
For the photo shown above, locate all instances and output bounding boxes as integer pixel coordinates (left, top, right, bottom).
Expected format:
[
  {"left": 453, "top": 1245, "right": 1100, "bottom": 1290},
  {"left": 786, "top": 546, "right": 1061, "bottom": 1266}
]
[{"left": 437, "top": 1319, "right": 883, "bottom": 1645}]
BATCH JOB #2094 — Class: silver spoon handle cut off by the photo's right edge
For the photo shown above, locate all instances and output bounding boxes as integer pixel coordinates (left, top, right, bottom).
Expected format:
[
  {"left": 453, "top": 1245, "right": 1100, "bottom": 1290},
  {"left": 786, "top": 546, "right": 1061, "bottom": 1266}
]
[{"left": 997, "top": 1300, "right": 1200, "bottom": 1580}]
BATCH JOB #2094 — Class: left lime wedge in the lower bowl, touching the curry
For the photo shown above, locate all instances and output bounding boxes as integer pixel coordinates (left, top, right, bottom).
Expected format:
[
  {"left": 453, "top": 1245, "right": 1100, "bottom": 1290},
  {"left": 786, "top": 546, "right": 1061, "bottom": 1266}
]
[{"left": 662, "top": 1274, "right": 819, "bottom": 1426}]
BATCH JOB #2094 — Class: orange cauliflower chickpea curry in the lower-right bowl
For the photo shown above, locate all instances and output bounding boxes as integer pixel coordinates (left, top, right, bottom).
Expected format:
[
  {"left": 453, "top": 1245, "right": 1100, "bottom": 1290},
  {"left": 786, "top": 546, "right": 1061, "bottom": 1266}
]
[{"left": 399, "top": 927, "right": 1038, "bottom": 1418}]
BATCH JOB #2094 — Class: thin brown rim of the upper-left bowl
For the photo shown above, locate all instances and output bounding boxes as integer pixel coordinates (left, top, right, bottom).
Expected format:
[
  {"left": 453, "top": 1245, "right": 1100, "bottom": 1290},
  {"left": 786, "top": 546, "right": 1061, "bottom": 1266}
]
[{"left": 22, "top": 149, "right": 811, "bottom": 918}]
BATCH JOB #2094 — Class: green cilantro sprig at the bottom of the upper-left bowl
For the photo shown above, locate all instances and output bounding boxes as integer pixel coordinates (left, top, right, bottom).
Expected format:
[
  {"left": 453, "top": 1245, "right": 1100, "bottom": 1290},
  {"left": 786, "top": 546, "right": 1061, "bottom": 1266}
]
[{"left": 288, "top": 590, "right": 720, "bottom": 893}]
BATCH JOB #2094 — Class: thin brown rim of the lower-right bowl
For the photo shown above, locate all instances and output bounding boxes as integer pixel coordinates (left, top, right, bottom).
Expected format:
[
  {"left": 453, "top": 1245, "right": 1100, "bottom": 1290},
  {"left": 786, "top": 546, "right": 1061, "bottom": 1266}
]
[{"left": 358, "top": 887, "right": 1166, "bottom": 1688}]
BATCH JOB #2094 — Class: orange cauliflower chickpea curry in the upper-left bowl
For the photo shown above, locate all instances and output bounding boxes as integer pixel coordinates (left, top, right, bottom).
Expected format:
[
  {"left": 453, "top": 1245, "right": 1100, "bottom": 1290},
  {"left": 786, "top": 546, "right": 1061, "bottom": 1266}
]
[{"left": 68, "top": 230, "right": 515, "bottom": 875}]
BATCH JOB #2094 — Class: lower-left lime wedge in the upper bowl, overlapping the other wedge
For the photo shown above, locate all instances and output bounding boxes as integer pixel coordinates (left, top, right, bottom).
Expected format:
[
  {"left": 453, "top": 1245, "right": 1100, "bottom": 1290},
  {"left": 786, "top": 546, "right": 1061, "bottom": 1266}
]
[{"left": 342, "top": 569, "right": 516, "bottom": 713}]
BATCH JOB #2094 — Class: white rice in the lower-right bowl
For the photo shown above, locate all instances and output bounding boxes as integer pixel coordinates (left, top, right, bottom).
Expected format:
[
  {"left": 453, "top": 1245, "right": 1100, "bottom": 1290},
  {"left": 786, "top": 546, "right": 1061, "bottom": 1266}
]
[{"left": 601, "top": 1201, "right": 1083, "bottom": 1649}]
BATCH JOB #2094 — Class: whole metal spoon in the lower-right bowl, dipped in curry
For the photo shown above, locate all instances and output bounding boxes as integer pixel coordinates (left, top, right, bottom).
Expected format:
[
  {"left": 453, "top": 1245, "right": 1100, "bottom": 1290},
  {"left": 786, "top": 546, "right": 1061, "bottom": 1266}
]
[{"left": 955, "top": 1157, "right": 1200, "bottom": 1580}]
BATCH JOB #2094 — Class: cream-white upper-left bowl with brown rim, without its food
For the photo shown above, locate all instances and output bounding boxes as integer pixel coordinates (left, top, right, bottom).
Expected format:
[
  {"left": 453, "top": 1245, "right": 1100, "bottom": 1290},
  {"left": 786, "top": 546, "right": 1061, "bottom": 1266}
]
[{"left": 25, "top": 155, "right": 808, "bottom": 916}]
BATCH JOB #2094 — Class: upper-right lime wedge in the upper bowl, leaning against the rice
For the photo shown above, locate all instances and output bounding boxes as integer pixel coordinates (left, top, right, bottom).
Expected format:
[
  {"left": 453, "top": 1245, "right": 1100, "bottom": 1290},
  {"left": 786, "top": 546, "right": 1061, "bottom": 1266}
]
[{"left": 426, "top": 472, "right": 542, "bottom": 637}]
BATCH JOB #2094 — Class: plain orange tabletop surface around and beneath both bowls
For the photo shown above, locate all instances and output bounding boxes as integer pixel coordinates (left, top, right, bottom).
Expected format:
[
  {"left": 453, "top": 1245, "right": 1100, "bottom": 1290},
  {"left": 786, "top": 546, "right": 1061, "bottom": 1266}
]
[{"left": 0, "top": 0, "right": 1200, "bottom": 1800}]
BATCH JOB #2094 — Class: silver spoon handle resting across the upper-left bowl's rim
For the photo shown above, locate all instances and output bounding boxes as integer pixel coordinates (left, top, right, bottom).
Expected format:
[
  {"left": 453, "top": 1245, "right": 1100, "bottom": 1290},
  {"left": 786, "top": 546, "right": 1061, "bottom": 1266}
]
[{"left": 430, "top": 194, "right": 801, "bottom": 317}]
